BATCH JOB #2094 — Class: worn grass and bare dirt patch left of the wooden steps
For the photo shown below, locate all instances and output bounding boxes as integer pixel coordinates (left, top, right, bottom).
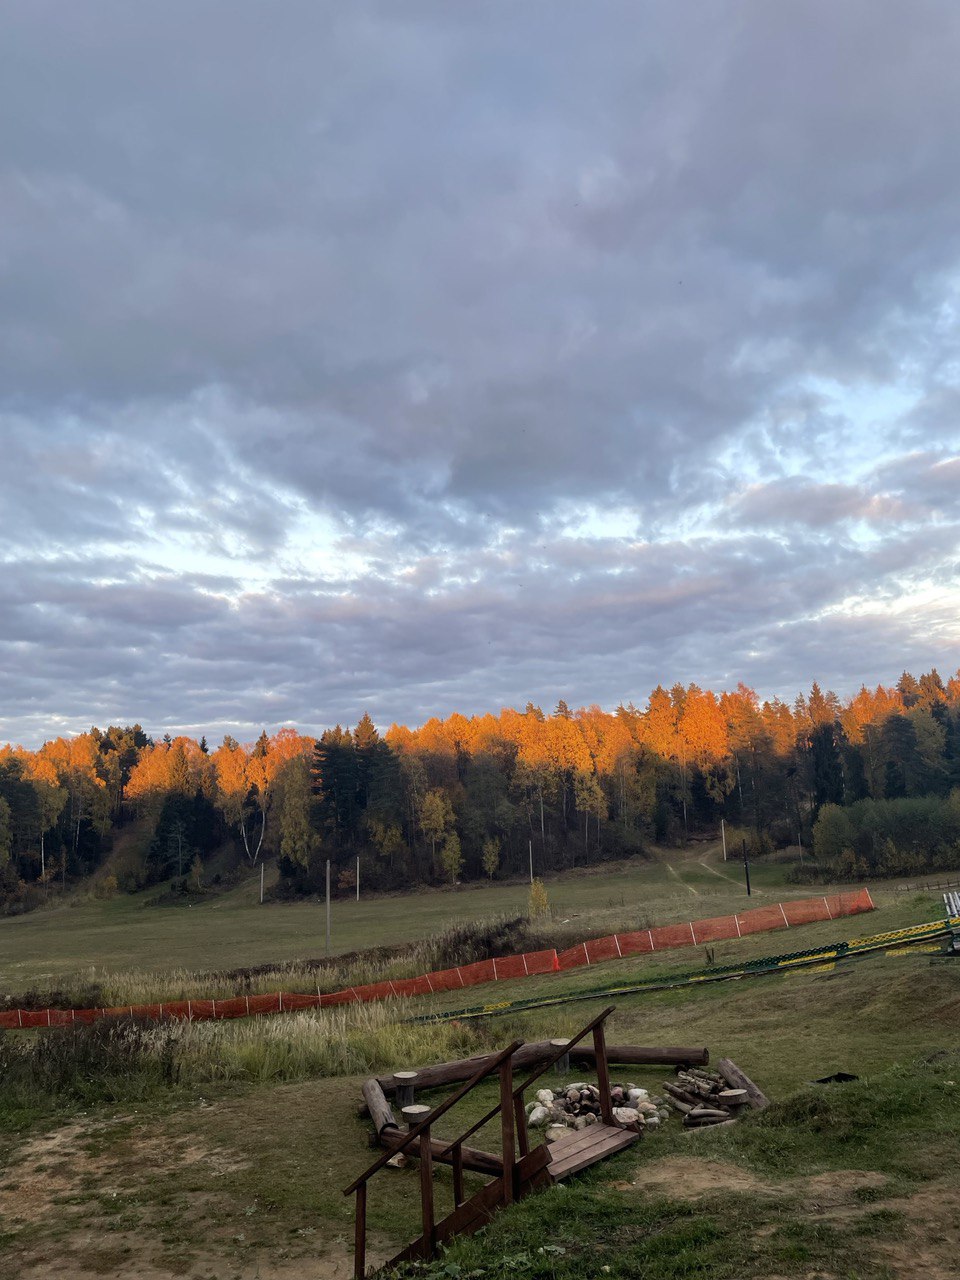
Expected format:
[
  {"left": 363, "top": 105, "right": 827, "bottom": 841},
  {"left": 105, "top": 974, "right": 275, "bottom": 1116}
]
[{"left": 0, "top": 1082, "right": 398, "bottom": 1280}]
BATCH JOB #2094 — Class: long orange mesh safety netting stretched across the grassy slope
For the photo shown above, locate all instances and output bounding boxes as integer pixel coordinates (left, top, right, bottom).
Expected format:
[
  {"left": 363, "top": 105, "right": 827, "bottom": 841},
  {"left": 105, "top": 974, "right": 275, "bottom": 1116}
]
[{"left": 0, "top": 888, "right": 874, "bottom": 1030}]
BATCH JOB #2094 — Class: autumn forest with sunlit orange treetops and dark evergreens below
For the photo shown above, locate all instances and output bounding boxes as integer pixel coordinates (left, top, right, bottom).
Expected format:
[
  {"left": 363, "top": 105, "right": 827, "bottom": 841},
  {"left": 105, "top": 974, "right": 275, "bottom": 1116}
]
[{"left": 0, "top": 669, "right": 960, "bottom": 913}]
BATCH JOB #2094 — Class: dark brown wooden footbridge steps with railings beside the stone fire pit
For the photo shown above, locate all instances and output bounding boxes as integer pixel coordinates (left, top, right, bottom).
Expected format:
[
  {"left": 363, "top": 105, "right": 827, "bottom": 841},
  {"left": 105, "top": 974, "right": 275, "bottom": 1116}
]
[{"left": 343, "top": 1007, "right": 639, "bottom": 1280}]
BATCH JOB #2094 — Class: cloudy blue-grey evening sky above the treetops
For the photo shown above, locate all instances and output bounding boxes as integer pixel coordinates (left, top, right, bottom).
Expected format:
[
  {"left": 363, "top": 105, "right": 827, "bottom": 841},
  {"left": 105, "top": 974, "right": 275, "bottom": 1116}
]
[{"left": 0, "top": 0, "right": 960, "bottom": 745}]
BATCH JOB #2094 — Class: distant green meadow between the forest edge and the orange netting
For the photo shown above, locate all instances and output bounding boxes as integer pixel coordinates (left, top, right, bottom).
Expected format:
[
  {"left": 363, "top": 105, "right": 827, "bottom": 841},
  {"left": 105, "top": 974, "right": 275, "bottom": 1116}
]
[{"left": 0, "top": 849, "right": 911, "bottom": 991}]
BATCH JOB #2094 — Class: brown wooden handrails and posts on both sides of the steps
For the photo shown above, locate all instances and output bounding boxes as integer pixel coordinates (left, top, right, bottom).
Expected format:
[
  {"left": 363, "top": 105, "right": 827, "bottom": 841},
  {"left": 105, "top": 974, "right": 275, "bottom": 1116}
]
[{"left": 343, "top": 1006, "right": 613, "bottom": 1280}]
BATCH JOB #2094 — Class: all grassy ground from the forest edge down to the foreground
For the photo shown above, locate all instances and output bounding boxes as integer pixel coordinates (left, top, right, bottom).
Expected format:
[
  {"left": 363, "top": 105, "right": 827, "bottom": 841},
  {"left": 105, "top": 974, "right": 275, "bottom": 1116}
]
[{"left": 0, "top": 851, "right": 960, "bottom": 1280}]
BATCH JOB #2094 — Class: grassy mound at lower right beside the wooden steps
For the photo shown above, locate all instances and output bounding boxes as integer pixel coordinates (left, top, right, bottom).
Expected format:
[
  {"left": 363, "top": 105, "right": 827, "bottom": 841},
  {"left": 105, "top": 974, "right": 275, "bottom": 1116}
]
[{"left": 411, "top": 1037, "right": 960, "bottom": 1280}]
